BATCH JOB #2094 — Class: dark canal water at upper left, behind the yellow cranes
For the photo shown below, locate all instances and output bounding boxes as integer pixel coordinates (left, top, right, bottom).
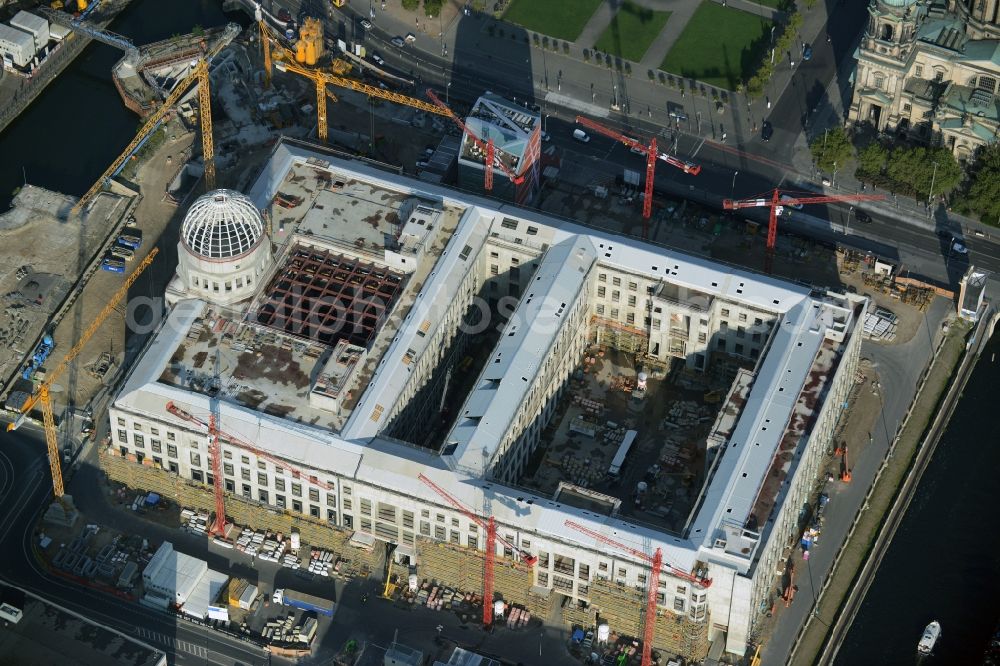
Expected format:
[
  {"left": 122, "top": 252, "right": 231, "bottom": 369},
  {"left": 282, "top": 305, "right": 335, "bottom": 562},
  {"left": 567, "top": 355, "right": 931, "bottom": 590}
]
[{"left": 0, "top": 0, "right": 242, "bottom": 211}]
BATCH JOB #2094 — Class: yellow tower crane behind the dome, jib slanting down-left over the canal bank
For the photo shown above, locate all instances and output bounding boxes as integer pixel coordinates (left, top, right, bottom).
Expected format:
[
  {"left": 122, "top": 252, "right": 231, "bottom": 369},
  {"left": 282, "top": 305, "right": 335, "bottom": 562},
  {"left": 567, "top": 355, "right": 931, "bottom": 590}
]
[{"left": 71, "top": 24, "right": 239, "bottom": 214}]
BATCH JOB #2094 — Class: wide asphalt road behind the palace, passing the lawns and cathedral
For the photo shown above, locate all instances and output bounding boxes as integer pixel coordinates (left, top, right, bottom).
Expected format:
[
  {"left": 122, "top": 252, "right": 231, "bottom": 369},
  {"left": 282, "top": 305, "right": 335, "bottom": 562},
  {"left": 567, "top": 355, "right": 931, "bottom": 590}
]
[{"left": 242, "top": 0, "right": 1000, "bottom": 285}]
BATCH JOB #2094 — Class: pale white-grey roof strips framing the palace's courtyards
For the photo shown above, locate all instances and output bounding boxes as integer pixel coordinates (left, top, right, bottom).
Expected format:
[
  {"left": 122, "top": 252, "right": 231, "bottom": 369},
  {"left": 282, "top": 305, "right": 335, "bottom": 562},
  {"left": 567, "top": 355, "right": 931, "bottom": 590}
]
[{"left": 116, "top": 142, "right": 863, "bottom": 572}]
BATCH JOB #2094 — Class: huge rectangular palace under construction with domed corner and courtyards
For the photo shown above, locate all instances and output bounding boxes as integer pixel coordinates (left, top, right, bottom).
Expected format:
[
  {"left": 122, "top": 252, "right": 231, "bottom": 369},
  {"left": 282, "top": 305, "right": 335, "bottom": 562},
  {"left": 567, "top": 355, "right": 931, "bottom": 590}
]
[{"left": 102, "top": 136, "right": 866, "bottom": 658}]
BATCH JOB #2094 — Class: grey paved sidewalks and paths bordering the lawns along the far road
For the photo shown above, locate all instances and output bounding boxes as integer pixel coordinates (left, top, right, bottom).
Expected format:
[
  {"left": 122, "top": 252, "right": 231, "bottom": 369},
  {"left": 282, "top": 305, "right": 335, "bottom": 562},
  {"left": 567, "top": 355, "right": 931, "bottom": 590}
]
[{"left": 349, "top": 0, "right": 990, "bottom": 234}]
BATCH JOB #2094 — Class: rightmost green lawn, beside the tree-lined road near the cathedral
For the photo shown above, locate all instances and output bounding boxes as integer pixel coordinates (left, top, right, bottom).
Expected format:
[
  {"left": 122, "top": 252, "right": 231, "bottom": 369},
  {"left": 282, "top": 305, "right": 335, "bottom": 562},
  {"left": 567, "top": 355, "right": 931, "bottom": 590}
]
[{"left": 660, "top": 2, "right": 772, "bottom": 90}]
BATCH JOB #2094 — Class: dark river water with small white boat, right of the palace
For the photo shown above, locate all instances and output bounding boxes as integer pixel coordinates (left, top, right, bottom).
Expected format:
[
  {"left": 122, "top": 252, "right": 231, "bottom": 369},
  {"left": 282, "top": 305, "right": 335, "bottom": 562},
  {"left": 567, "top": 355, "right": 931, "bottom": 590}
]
[{"left": 836, "top": 334, "right": 1000, "bottom": 666}]
